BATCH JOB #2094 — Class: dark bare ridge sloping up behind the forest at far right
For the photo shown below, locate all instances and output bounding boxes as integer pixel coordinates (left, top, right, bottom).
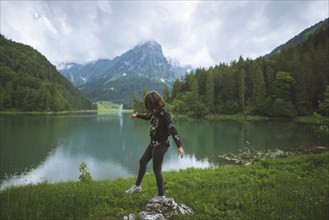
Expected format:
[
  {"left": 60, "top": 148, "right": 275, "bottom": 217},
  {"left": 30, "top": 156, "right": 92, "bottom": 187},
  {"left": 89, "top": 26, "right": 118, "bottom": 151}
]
[{"left": 264, "top": 18, "right": 329, "bottom": 59}]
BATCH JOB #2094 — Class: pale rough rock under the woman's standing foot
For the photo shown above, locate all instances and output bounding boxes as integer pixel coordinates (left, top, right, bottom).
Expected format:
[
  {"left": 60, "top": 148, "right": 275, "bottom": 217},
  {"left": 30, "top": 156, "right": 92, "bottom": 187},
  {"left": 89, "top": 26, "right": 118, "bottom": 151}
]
[{"left": 138, "top": 197, "right": 194, "bottom": 220}]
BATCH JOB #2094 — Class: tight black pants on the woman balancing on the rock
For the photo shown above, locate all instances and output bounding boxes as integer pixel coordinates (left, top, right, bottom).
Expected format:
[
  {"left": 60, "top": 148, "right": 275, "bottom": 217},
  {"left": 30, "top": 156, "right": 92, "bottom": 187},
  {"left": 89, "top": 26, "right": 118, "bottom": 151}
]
[{"left": 135, "top": 144, "right": 169, "bottom": 196}]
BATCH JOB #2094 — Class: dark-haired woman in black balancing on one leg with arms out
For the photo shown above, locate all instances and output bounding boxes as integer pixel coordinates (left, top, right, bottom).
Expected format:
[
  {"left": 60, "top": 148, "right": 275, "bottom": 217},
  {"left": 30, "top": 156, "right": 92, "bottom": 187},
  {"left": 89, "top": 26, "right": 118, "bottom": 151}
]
[{"left": 126, "top": 91, "right": 184, "bottom": 202}]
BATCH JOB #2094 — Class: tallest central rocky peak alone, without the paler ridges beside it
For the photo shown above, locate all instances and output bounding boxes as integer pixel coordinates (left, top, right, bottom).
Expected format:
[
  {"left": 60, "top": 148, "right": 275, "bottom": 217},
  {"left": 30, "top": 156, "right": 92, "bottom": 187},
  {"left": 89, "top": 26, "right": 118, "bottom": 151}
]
[{"left": 78, "top": 41, "right": 175, "bottom": 107}]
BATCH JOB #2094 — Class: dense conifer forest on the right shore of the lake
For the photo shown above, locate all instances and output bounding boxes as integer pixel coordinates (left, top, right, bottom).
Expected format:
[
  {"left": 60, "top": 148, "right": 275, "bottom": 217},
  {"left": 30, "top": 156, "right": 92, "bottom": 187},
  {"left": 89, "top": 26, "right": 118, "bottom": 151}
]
[{"left": 134, "top": 20, "right": 329, "bottom": 117}]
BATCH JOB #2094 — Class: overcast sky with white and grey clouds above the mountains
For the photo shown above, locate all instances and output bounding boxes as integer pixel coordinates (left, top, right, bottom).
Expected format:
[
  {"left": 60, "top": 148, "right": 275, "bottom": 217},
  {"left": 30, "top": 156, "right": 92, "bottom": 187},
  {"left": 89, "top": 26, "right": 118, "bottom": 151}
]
[{"left": 0, "top": 0, "right": 329, "bottom": 67}]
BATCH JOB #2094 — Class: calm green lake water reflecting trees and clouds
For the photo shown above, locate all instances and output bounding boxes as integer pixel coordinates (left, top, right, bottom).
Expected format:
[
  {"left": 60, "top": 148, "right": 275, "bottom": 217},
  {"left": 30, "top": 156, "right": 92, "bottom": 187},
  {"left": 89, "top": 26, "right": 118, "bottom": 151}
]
[{"left": 0, "top": 113, "right": 329, "bottom": 188}]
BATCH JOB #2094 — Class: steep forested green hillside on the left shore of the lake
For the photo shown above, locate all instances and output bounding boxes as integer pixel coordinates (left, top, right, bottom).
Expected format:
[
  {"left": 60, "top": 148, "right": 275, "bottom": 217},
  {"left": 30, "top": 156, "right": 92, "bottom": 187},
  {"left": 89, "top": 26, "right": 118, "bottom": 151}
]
[{"left": 0, "top": 35, "right": 93, "bottom": 111}]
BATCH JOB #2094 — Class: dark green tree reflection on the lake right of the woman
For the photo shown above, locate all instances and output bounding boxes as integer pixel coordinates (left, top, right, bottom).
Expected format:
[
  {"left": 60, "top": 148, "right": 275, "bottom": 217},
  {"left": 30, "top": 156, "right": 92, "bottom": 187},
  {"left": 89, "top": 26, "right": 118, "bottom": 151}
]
[{"left": 175, "top": 119, "right": 328, "bottom": 165}]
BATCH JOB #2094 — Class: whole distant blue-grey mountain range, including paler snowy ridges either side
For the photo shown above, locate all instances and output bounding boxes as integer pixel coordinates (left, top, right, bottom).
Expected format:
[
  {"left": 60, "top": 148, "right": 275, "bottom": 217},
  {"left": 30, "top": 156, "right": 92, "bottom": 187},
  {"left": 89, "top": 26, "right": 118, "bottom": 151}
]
[{"left": 58, "top": 40, "right": 192, "bottom": 107}]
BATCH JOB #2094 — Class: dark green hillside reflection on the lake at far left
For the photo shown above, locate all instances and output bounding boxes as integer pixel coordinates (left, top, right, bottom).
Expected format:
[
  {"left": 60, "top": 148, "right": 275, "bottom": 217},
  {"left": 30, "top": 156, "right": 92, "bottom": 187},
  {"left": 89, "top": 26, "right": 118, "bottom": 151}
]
[{"left": 0, "top": 116, "right": 81, "bottom": 178}]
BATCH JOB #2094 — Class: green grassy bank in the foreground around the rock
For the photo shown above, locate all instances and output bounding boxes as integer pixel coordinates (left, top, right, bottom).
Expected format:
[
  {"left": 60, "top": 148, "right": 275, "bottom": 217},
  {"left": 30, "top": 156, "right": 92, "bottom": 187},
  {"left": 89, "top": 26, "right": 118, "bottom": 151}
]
[{"left": 0, "top": 152, "right": 329, "bottom": 219}]
